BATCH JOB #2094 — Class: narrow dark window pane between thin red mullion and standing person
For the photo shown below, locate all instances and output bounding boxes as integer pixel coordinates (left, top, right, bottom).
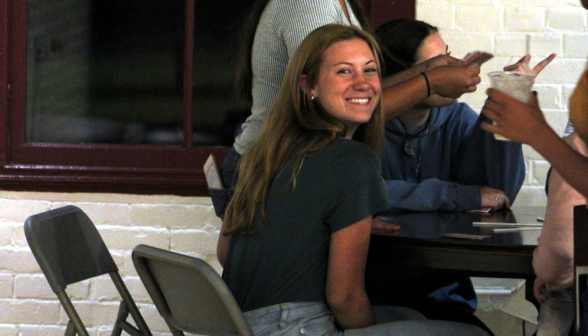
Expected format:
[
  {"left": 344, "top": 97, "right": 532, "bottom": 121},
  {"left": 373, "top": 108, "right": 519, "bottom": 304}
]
[{"left": 193, "top": 0, "right": 253, "bottom": 146}]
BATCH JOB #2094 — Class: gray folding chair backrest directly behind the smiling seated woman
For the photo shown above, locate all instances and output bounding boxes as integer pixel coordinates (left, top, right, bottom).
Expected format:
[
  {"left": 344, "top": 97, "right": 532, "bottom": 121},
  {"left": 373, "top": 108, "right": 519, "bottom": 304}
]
[{"left": 133, "top": 245, "right": 253, "bottom": 336}]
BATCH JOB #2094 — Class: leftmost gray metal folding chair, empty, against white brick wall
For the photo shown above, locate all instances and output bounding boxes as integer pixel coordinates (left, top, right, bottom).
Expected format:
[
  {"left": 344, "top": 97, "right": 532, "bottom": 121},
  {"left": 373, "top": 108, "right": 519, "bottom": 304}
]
[{"left": 24, "top": 205, "right": 152, "bottom": 336}]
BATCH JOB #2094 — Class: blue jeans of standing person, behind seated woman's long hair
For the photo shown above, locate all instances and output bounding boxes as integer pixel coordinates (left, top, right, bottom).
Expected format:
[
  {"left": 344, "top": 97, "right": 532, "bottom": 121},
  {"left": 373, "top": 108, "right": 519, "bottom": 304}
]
[{"left": 208, "top": 148, "right": 241, "bottom": 218}]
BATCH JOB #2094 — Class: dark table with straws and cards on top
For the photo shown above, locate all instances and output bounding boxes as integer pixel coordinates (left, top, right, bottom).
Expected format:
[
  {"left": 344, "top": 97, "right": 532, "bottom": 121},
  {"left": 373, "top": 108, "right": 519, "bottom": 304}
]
[{"left": 366, "top": 207, "right": 545, "bottom": 305}]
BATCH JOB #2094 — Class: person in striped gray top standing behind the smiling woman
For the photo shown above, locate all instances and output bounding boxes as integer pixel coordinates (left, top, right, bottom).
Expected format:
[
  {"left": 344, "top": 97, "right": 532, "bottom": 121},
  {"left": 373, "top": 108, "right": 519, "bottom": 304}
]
[{"left": 210, "top": 0, "right": 480, "bottom": 217}]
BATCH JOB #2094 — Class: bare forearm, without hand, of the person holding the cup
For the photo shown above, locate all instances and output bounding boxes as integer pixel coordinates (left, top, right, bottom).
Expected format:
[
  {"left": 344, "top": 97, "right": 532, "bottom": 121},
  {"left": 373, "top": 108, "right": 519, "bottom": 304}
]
[{"left": 529, "top": 127, "right": 588, "bottom": 197}]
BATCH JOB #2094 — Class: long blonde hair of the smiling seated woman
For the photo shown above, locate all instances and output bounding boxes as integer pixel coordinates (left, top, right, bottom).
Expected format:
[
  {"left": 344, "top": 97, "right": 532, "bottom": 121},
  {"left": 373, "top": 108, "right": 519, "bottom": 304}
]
[{"left": 224, "top": 24, "right": 384, "bottom": 235}]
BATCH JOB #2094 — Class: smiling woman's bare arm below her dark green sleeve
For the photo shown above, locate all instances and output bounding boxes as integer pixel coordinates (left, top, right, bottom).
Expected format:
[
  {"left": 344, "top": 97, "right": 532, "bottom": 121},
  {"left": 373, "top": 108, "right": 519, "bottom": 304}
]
[{"left": 326, "top": 216, "right": 375, "bottom": 329}]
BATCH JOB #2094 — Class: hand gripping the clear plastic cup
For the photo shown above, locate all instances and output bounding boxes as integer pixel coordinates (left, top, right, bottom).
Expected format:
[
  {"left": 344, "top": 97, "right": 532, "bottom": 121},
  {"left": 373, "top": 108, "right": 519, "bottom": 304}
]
[{"left": 482, "top": 89, "right": 551, "bottom": 146}]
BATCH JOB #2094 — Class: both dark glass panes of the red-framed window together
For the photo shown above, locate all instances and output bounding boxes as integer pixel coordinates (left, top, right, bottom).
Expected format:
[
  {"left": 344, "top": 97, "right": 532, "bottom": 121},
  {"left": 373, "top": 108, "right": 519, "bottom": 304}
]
[{"left": 25, "top": 0, "right": 251, "bottom": 146}]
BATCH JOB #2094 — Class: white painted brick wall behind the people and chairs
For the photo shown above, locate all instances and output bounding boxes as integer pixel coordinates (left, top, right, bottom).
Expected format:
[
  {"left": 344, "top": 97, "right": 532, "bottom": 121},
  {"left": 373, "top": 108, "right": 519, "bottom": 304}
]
[{"left": 0, "top": 0, "right": 588, "bottom": 336}]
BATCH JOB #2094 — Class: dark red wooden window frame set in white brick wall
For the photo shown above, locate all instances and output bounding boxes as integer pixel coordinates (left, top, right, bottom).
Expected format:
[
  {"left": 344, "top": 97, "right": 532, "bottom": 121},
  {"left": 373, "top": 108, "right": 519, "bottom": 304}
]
[{"left": 0, "top": 0, "right": 414, "bottom": 196}]
